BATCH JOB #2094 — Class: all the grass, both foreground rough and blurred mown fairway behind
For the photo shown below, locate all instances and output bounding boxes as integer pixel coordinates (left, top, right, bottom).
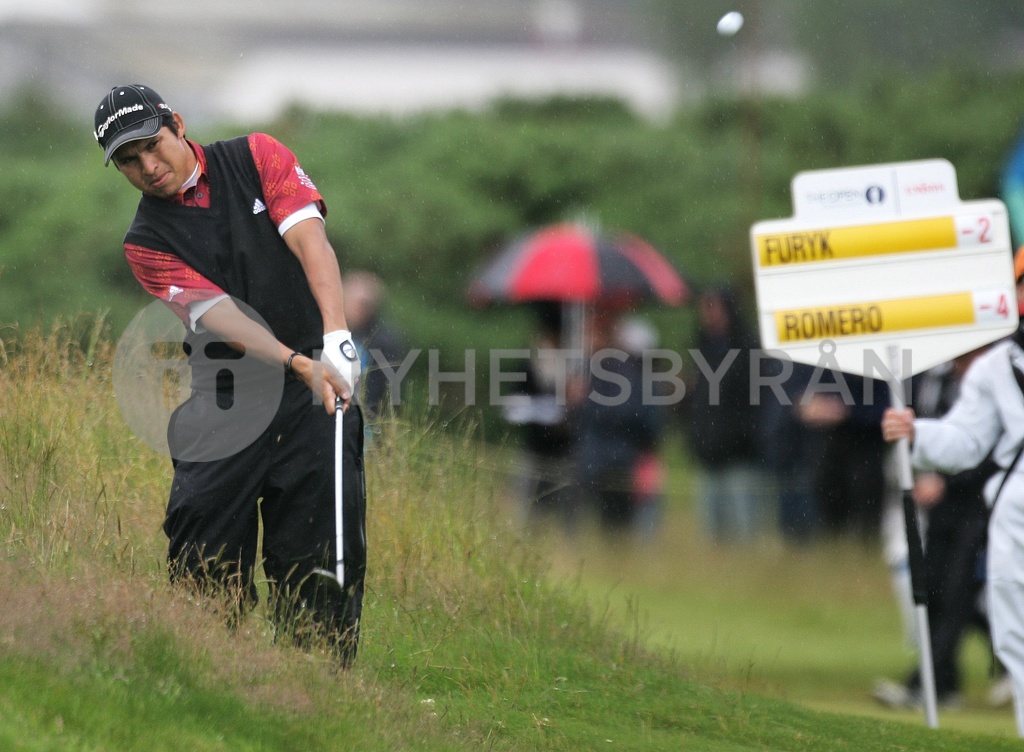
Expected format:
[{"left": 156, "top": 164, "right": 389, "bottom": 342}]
[{"left": 0, "top": 325, "right": 1018, "bottom": 752}]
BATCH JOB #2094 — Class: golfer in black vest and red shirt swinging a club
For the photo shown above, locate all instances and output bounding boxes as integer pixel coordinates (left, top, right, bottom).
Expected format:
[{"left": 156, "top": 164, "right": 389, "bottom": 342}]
[{"left": 94, "top": 84, "right": 366, "bottom": 665}]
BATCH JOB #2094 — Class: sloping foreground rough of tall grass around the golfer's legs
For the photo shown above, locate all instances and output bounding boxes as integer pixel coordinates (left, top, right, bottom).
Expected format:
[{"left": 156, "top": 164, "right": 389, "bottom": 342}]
[{"left": 0, "top": 318, "right": 1013, "bottom": 752}]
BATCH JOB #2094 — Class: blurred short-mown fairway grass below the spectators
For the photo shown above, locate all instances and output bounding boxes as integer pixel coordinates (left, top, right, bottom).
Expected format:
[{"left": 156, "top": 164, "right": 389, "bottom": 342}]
[{"left": 549, "top": 449, "right": 1017, "bottom": 738}]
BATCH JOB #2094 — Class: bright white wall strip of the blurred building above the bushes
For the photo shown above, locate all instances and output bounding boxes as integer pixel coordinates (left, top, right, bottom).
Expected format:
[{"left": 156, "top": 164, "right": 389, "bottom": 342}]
[{"left": 219, "top": 44, "right": 678, "bottom": 120}]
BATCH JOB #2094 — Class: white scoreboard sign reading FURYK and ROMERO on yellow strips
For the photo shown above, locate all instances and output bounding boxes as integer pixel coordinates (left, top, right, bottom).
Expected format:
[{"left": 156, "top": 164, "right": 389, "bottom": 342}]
[{"left": 751, "top": 160, "right": 1017, "bottom": 376}]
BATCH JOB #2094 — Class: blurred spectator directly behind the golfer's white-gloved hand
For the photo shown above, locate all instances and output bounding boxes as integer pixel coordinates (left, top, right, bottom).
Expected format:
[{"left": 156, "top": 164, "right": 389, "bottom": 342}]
[{"left": 344, "top": 270, "right": 407, "bottom": 419}]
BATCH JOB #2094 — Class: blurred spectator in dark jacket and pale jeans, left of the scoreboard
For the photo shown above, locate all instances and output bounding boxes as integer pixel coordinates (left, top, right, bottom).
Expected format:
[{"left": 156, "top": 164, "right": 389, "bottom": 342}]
[{"left": 683, "top": 287, "right": 767, "bottom": 542}]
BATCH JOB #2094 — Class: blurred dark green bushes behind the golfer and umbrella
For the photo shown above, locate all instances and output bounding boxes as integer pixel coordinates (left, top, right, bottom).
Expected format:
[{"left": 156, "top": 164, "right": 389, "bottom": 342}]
[{"left": 6, "top": 72, "right": 1024, "bottom": 367}]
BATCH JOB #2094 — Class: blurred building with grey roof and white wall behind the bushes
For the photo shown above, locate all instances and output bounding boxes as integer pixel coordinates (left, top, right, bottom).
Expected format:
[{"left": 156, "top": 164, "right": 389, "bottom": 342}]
[{"left": 0, "top": 0, "right": 688, "bottom": 120}]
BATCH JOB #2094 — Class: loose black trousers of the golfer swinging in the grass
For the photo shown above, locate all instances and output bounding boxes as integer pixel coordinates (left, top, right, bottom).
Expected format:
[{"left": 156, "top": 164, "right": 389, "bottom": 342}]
[{"left": 164, "top": 378, "right": 367, "bottom": 655}]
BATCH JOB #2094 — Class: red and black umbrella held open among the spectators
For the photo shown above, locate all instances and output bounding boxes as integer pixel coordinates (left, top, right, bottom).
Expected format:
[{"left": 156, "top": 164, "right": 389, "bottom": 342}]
[{"left": 469, "top": 223, "right": 689, "bottom": 306}]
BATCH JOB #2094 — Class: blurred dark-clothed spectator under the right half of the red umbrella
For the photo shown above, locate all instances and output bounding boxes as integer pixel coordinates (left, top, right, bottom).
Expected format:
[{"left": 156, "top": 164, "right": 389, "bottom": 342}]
[{"left": 572, "top": 310, "right": 664, "bottom": 533}]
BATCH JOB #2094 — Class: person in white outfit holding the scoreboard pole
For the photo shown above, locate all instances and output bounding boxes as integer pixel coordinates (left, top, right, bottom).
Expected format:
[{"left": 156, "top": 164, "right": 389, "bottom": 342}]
[{"left": 882, "top": 251, "right": 1024, "bottom": 737}]
